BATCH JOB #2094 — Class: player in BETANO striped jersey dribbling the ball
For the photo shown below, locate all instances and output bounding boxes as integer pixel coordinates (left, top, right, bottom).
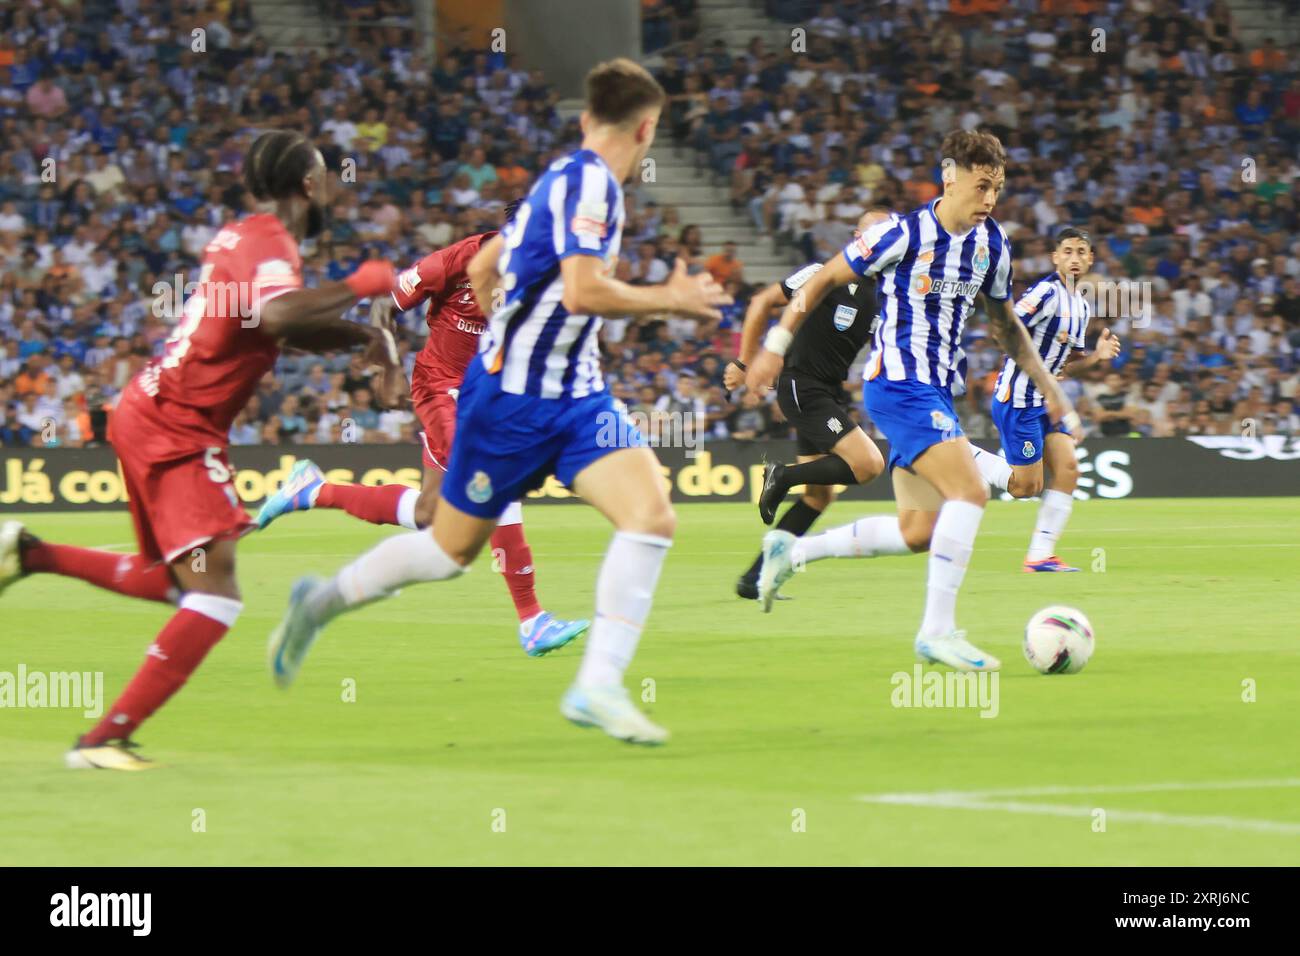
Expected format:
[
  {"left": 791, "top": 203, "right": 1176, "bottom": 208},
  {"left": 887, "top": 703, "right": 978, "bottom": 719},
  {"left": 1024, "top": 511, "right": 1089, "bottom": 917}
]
[{"left": 746, "top": 130, "right": 1079, "bottom": 671}]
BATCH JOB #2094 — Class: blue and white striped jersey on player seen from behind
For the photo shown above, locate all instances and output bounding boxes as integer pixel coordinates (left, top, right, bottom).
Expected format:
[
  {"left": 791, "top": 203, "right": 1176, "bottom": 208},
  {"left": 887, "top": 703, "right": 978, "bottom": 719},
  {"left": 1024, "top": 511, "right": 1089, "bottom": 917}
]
[{"left": 480, "top": 150, "right": 624, "bottom": 398}]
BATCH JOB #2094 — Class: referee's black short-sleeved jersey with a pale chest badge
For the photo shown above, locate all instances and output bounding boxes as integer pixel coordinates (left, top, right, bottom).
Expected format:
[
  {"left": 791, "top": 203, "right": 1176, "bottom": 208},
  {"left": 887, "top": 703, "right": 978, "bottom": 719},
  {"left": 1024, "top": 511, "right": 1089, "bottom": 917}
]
[{"left": 781, "top": 263, "right": 879, "bottom": 385}]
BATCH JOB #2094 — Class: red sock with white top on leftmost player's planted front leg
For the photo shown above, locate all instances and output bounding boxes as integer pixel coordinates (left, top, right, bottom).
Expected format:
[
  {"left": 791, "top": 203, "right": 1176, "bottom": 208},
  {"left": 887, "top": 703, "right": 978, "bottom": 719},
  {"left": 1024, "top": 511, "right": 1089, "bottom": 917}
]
[{"left": 81, "top": 592, "right": 242, "bottom": 747}]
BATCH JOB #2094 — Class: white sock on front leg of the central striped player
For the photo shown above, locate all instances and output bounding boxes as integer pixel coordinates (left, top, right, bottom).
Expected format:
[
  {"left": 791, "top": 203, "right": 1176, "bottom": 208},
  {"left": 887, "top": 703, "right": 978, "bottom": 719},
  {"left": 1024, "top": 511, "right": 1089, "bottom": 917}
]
[{"left": 577, "top": 531, "right": 672, "bottom": 687}]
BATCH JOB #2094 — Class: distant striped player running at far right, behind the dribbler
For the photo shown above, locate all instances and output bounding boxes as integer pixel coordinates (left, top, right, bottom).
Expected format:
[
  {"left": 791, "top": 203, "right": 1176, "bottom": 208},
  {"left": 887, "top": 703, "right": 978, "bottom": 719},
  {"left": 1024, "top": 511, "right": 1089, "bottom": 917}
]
[{"left": 971, "top": 226, "right": 1119, "bottom": 572}]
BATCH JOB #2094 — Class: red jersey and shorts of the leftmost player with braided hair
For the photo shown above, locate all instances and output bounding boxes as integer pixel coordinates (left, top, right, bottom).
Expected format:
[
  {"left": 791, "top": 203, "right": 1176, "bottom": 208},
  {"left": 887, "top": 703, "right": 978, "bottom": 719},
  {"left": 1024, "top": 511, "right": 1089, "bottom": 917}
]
[{"left": 109, "top": 215, "right": 303, "bottom": 563}]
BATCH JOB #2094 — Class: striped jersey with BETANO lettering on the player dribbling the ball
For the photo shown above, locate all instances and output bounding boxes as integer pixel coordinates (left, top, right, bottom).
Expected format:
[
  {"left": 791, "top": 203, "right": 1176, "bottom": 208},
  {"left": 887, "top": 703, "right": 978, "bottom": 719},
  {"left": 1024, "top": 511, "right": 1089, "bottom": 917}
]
[{"left": 844, "top": 199, "right": 1011, "bottom": 388}]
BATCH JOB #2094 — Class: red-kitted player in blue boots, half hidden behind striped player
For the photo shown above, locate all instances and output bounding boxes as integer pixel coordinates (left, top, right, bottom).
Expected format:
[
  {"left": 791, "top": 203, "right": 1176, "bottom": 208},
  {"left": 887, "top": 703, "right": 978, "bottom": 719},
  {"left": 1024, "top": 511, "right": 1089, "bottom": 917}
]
[{"left": 257, "top": 202, "right": 590, "bottom": 657}]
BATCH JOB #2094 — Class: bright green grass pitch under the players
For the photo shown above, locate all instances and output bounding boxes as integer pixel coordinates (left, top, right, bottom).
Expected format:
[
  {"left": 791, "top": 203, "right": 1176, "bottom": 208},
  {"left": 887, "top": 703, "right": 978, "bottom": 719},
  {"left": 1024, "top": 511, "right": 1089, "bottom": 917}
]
[{"left": 0, "top": 498, "right": 1300, "bottom": 865}]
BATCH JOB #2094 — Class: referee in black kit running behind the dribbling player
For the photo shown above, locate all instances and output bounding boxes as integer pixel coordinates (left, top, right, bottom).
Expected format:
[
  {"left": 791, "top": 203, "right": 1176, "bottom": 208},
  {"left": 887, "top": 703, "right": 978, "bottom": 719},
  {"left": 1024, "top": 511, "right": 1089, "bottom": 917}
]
[{"left": 723, "top": 206, "right": 891, "bottom": 600}]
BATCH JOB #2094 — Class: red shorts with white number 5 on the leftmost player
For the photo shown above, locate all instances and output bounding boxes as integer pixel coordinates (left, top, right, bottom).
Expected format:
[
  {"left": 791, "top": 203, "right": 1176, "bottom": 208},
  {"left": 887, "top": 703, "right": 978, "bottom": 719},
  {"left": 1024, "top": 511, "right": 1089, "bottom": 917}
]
[{"left": 111, "top": 392, "right": 256, "bottom": 564}]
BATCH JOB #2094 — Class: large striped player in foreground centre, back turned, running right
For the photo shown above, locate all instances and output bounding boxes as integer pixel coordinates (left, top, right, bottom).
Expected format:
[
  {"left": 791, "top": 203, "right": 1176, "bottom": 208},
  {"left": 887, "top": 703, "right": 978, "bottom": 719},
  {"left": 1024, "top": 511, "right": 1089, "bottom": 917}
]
[{"left": 269, "top": 59, "right": 731, "bottom": 744}]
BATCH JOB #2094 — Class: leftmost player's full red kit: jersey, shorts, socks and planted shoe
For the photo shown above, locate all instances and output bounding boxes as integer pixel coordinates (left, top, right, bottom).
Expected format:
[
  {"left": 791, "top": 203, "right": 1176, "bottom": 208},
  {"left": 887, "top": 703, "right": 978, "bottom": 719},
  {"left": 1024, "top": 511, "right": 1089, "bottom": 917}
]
[{"left": 22, "top": 215, "right": 319, "bottom": 770}]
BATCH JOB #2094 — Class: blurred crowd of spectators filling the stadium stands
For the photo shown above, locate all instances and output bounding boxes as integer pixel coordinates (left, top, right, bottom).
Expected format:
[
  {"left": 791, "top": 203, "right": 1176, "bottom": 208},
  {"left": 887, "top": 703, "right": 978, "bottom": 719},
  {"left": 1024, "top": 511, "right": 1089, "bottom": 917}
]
[{"left": 0, "top": 0, "right": 1300, "bottom": 455}]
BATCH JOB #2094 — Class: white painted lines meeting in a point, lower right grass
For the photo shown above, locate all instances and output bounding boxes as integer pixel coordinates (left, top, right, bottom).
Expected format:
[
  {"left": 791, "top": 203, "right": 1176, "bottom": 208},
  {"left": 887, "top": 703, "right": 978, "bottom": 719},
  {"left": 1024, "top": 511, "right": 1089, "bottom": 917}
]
[{"left": 854, "top": 778, "right": 1300, "bottom": 836}]
